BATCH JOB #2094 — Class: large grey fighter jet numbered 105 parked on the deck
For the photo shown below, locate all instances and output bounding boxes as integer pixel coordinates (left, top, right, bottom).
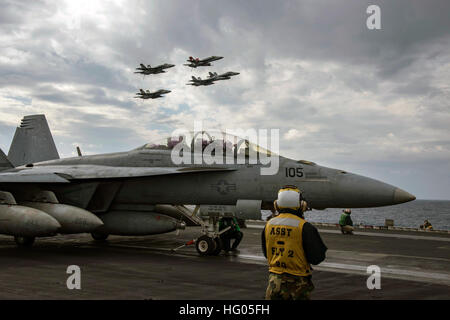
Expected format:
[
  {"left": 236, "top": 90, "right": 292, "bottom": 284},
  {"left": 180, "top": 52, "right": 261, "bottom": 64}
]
[{"left": 0, "top": 115, "right": 415, "bottom": 255}]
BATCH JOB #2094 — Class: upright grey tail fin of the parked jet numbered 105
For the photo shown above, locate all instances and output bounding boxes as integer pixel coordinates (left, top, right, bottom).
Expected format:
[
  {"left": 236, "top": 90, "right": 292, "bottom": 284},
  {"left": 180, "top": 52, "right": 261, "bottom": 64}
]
[{"left": 8, "top": 114, "right": 59, "bottom": 166}]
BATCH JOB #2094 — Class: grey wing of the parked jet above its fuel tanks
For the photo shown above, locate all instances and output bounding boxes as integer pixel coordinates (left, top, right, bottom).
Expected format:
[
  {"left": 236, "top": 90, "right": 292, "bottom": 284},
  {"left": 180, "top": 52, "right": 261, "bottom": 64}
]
[{"left": 0, "top": 165, "right": 236, "bottom": 183}]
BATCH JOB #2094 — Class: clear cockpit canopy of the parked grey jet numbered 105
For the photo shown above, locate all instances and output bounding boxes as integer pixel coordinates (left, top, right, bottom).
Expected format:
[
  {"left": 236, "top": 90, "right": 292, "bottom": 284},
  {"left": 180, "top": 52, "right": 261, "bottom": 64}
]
[{"left": 137, "top": 131, "right": 275, "bottom": 157}]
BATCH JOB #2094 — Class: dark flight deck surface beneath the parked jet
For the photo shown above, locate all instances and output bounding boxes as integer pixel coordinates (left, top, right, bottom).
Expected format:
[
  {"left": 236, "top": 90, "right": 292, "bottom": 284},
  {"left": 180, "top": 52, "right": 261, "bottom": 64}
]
[{"left": 0, "top": 225, "right": 450, "bottom": 300}]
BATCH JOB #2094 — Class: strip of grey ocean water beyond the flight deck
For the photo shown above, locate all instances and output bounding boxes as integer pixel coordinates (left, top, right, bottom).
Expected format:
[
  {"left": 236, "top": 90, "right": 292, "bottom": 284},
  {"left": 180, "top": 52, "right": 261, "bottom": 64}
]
[{"left": 263, "top": 200, "right": 450, "bottom": 230}]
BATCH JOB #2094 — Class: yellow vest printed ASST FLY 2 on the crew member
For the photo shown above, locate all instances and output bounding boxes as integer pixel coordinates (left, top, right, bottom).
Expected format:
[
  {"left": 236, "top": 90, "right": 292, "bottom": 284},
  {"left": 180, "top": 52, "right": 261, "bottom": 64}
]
[{"left": 265, "top": 213, "right": 311, "bottom": 276}]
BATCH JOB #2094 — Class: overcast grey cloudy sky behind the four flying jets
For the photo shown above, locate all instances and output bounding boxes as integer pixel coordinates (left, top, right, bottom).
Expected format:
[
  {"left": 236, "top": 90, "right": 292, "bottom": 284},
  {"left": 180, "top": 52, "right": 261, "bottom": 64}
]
[{"left": 0, "top": 0, "right": 450, "bottom": 200}]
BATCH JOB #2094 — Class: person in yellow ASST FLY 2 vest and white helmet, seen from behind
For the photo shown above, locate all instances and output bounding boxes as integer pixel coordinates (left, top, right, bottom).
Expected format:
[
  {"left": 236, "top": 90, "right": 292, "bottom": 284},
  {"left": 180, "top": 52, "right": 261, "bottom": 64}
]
[{"left": 261, "top": 186, "right": 327, "bottom": 300}]
